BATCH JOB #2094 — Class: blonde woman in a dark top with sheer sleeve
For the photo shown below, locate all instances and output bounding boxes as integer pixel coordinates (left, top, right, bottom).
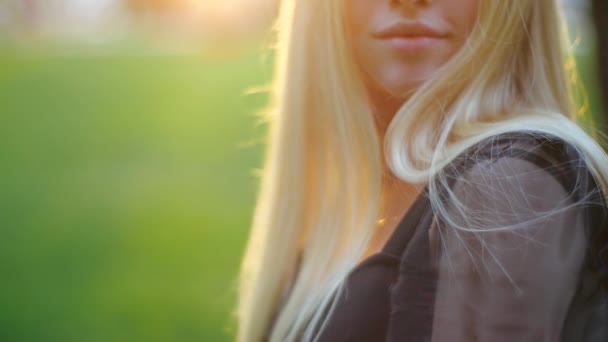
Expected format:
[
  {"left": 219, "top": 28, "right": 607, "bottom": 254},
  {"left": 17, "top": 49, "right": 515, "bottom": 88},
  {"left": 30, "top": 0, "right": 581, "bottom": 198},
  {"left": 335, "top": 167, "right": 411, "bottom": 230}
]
[{"left": 237, "top": 0, "right": 608, "bottom": 342}]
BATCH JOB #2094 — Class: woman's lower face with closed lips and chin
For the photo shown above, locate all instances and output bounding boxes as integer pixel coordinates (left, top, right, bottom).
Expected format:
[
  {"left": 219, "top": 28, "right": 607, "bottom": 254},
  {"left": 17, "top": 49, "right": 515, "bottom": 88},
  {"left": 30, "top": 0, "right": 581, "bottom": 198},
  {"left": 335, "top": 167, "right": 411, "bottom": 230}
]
[{"left": 344, "top": 0, "right": 479, "bottom": 103}]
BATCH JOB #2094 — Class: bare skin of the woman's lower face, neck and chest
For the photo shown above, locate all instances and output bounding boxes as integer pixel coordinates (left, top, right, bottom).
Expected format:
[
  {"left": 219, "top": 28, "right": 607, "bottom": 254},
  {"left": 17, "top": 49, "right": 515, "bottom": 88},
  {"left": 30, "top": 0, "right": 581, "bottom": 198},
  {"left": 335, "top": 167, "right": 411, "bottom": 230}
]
[{"left": 345, "top": 0, "right": 479, "bottom": 262}]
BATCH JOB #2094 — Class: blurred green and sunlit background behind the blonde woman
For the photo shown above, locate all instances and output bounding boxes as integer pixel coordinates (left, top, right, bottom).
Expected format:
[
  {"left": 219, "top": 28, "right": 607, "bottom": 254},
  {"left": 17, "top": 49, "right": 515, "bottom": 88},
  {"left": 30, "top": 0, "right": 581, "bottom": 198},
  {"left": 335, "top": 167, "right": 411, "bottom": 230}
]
[{"left": 0, "top": 0, "right": 603, "bottom": 342}]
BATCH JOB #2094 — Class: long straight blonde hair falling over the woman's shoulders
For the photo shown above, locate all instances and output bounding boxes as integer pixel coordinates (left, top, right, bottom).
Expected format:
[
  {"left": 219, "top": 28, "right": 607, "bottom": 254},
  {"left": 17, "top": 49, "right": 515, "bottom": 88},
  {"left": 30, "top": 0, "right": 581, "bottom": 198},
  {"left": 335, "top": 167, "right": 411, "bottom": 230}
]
[{"left": 236, "top": 0, "right": 608, "bottom": 342}]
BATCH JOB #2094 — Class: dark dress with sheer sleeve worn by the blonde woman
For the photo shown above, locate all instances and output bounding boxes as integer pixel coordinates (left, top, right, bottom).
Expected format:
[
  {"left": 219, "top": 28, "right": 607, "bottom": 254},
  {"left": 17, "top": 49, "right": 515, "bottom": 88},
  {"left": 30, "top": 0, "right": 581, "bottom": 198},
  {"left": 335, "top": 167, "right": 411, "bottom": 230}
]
[{"left": 306, "top": 132, "right": 608, "bottom": 342}]
